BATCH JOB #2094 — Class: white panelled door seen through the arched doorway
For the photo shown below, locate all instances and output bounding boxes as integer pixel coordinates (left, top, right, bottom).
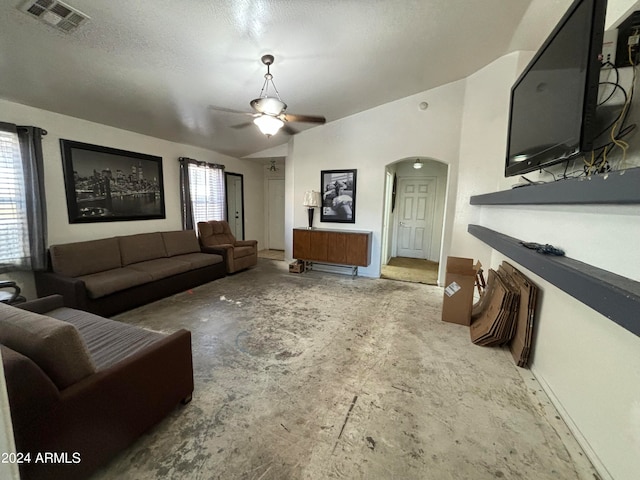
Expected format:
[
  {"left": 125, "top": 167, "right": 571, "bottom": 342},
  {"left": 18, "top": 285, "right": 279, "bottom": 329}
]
[{"left": 396, "top": 177, "right": 436, "bottom": 258}]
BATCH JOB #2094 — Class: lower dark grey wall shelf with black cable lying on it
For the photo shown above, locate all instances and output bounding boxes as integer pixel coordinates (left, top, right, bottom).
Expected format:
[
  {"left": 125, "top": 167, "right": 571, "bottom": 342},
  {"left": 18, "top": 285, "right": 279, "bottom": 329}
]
[{"left": 467, "top": 224, "right": 640, "bottom": 336}]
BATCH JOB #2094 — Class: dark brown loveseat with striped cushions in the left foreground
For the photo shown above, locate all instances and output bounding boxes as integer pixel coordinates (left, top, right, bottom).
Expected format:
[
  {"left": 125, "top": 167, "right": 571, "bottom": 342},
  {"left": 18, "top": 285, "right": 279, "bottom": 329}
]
[{"left": 0, "top": 295, "right": 193, "bottom": 480}]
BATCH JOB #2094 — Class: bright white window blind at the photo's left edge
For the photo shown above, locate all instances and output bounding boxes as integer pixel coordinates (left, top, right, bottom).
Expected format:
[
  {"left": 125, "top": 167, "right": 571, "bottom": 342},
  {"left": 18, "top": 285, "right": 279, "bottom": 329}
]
[{"left": 0, "top": 130, "right": 29, "bottom": 269}]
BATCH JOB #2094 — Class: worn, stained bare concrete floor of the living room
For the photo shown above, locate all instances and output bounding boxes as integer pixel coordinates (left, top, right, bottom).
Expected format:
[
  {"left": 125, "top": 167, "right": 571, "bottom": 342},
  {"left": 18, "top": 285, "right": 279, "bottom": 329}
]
[{"left": 94, "top": 260, "right": 597, "bottom": 480}]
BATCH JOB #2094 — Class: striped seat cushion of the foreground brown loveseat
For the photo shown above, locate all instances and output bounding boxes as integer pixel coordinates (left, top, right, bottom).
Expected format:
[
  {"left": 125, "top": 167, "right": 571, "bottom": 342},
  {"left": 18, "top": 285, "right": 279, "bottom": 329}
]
[{"left": 47, "top": 307, "right": 166, "bottom": 371}]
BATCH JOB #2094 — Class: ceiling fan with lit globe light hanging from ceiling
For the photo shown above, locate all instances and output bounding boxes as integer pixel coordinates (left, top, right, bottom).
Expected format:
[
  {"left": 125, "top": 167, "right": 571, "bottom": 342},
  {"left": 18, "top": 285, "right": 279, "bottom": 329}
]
[{"left": 209, "top": 55, "right": 327, "bottom": 137}]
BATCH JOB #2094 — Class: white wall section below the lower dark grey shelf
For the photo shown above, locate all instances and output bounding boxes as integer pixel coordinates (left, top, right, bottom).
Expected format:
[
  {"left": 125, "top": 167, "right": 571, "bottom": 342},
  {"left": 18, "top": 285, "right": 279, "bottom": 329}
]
[{"left": 492, "top": 249, "right": 640, "bottom": 480}]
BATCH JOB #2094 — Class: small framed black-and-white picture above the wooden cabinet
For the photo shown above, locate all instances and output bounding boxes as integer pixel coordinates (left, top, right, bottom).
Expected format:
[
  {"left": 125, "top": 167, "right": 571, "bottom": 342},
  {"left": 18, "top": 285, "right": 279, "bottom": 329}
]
[{"left": 320, "top": 170, "right": 356, "bottom": 223}]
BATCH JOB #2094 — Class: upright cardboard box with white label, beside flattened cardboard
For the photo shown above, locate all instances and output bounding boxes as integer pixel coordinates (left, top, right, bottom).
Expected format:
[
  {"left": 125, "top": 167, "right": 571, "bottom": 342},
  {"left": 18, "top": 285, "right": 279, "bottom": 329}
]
[{"left": 442, "top": 257, "right": 482, "bottom": 326}]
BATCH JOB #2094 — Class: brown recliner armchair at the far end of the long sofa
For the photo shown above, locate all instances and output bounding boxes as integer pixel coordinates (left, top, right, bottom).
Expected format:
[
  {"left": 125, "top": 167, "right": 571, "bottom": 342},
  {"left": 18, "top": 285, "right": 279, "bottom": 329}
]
[{"left": 198, "top": 220, "right": 258, "bottom": 273}]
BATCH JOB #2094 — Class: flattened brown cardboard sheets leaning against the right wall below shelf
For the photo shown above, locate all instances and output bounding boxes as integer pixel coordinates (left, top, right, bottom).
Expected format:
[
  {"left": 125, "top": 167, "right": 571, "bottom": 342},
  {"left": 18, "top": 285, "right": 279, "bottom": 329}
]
[{"left": 470, "top": 262, "right": 536, "bottom": 367}]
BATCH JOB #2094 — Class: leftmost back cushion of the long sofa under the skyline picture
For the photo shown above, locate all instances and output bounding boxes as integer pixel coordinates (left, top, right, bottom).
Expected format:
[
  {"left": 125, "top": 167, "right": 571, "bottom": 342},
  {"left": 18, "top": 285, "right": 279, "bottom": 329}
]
[{"left": 49, "top": 237, "right": 121, "bottom": 277}]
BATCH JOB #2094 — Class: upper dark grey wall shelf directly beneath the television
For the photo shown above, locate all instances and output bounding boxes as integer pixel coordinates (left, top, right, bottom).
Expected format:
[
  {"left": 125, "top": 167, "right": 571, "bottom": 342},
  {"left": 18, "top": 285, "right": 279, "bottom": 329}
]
[{"left": 470, "top": 167, "right": 640, "bottom": 205}]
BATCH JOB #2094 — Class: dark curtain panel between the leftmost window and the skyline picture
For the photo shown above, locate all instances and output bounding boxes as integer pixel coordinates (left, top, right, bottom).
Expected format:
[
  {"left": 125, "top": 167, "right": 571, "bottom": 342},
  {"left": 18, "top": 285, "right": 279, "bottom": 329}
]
[{"left": 17, "top": 126, "right": 47, "bottom": 270}]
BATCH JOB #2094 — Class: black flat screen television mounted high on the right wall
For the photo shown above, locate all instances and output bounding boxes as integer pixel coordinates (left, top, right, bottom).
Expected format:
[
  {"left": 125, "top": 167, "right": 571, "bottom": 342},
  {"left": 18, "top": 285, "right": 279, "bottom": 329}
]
[{"left": 505, "top": 0, "right": 607, "bottom": 177}]
